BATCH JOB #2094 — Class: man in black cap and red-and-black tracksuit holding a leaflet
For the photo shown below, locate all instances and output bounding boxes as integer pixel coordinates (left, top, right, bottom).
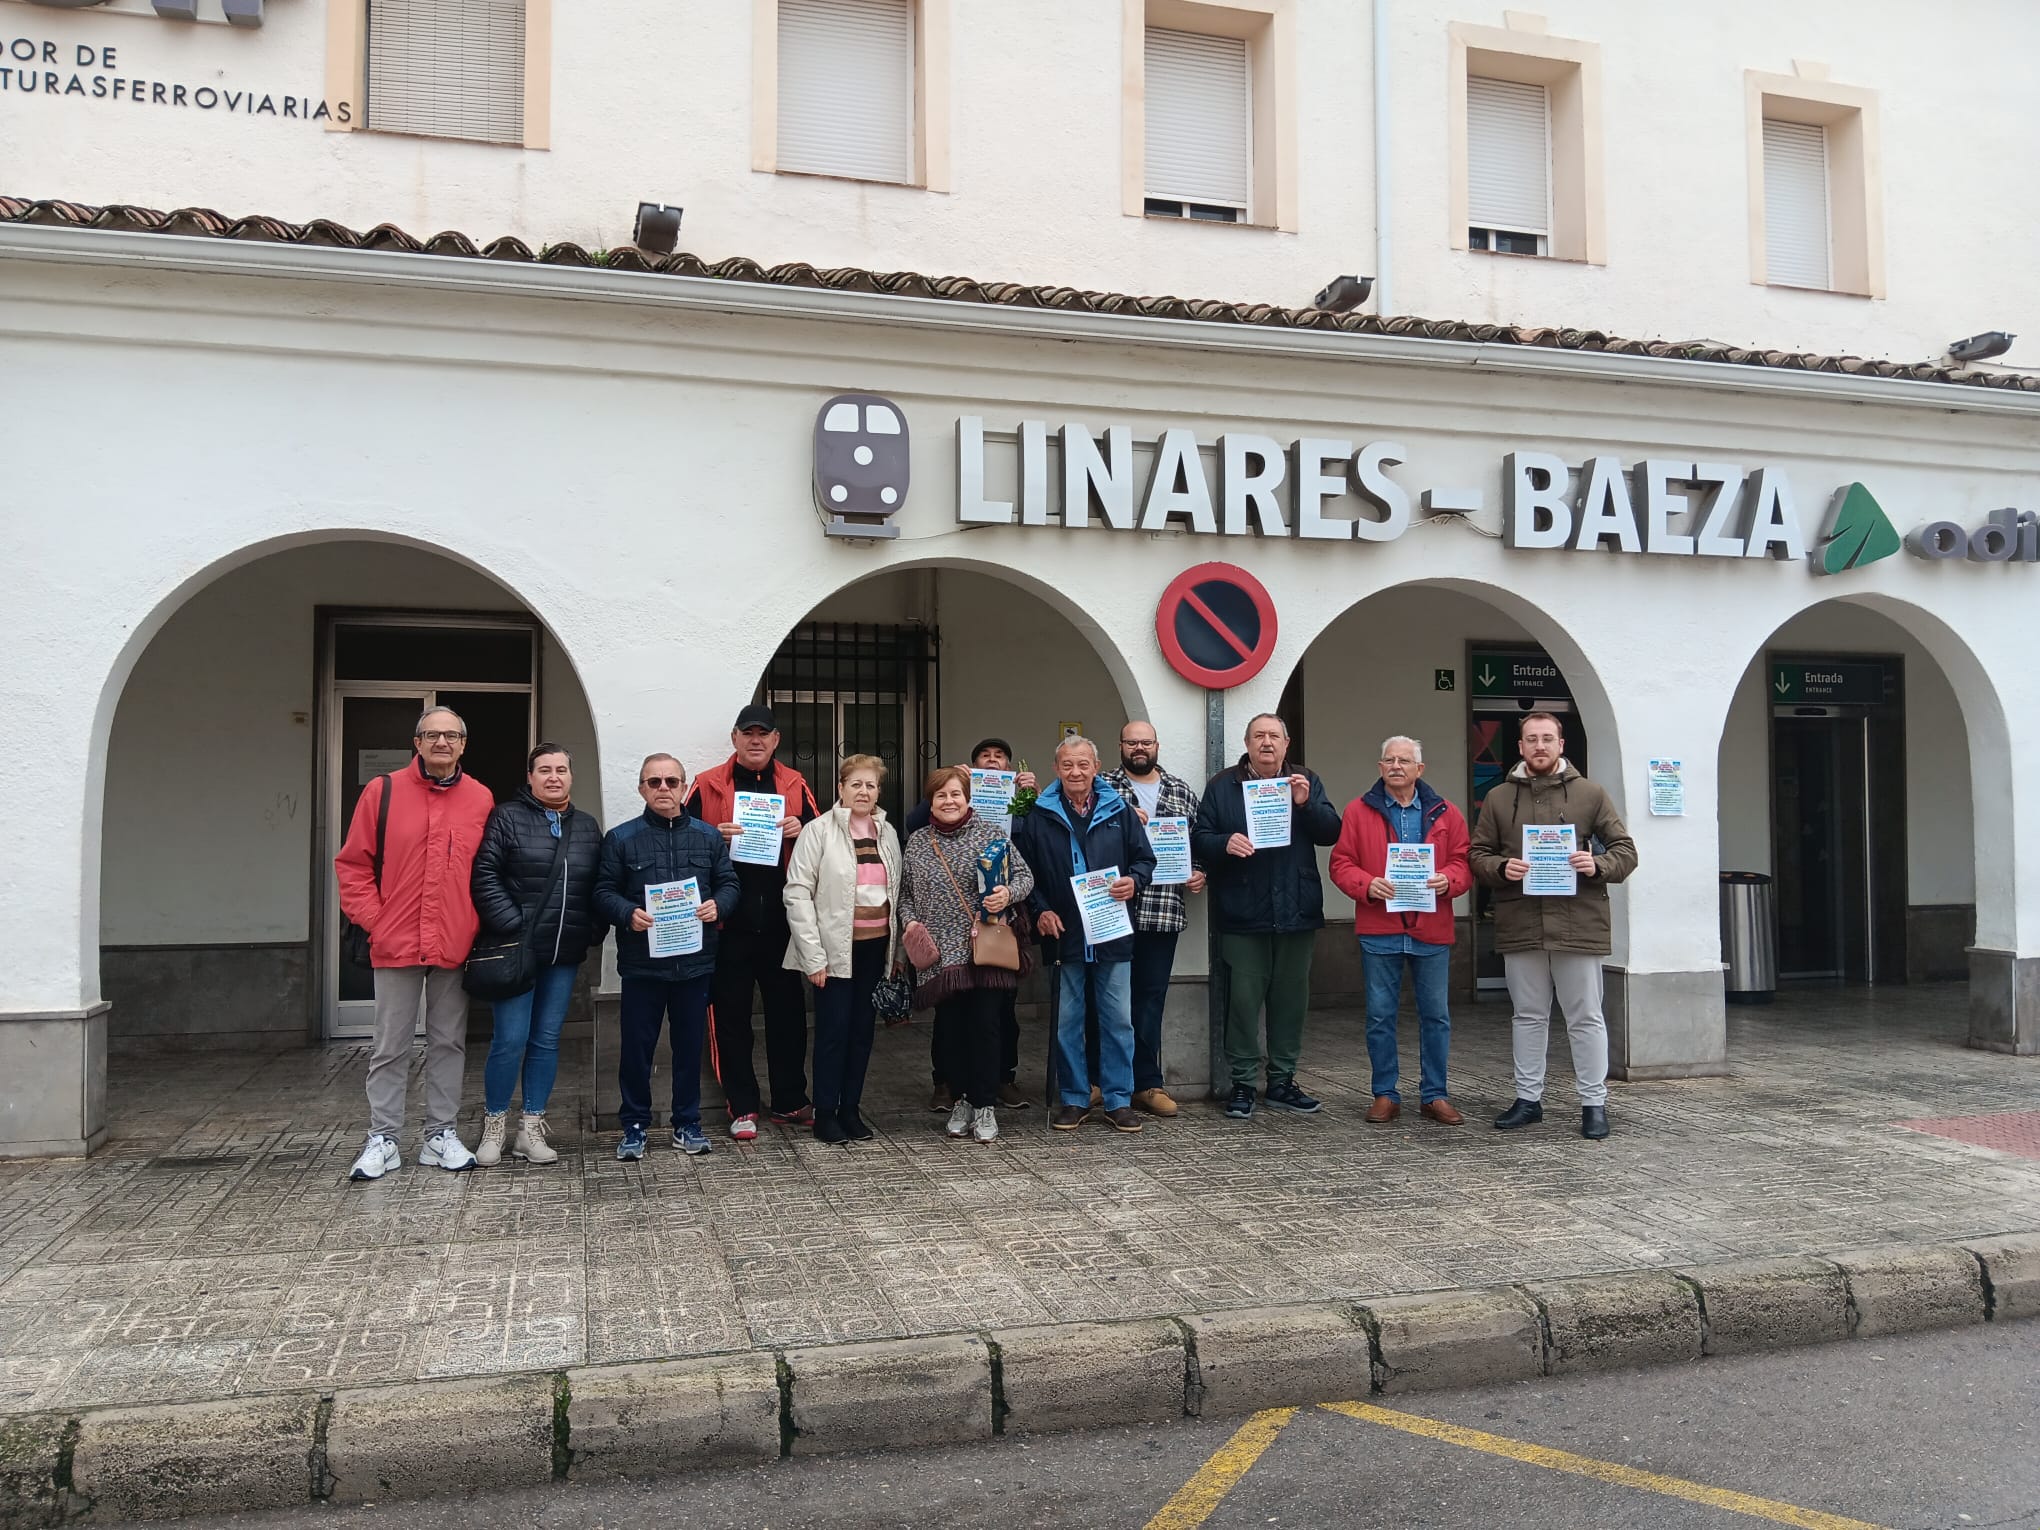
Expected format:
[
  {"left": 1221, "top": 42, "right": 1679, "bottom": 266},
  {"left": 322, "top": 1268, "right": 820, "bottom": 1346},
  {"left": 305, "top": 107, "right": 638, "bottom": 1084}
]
[{"left": 687, "top": 706, "right": 820, "bottom": 1142}]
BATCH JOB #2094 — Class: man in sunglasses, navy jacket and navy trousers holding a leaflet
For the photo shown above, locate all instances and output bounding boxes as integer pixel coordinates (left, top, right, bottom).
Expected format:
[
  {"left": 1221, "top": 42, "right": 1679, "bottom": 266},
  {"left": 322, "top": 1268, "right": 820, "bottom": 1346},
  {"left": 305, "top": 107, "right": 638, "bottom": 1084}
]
[{"left": 596, "top": 755, "right": 741, "bottom": 1159}]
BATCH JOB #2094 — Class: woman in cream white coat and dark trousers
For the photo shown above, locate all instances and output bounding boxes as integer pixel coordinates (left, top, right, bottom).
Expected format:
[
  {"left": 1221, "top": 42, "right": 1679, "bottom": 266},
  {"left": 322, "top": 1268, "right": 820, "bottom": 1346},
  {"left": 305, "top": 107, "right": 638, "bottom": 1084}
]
[{"left": 785, "top": 755, "right": 900, "bottom": 1142}]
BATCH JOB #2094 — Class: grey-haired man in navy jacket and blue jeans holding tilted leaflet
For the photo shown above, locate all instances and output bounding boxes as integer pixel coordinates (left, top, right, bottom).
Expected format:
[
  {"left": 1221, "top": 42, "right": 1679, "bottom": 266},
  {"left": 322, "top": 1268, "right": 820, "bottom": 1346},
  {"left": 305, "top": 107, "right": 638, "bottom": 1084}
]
[{"left": 1014, "top": 736, "right": 1155, "bottom": 1132}]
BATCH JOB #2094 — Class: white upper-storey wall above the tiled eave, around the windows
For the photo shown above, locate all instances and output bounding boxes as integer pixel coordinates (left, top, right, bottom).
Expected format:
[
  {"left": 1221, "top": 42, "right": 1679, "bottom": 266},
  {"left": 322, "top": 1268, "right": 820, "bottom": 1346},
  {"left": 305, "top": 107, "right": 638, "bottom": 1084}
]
[{"left": 0, "top": 0, "right": 2040, "bottom": 367}]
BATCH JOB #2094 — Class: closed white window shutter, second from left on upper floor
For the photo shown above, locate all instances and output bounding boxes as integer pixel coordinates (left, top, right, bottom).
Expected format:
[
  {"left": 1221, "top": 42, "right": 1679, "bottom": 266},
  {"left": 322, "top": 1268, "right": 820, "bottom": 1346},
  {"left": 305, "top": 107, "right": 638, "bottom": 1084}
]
[{"left": 779, "top": 0, "right": 914, "bottom": 184}]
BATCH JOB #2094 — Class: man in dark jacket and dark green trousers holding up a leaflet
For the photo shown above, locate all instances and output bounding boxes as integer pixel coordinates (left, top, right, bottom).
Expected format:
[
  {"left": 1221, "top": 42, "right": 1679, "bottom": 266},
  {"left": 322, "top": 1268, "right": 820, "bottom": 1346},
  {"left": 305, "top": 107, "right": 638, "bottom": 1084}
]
[{"left": 1189, "top": 712, "right": 1338, "bottom": 1120}]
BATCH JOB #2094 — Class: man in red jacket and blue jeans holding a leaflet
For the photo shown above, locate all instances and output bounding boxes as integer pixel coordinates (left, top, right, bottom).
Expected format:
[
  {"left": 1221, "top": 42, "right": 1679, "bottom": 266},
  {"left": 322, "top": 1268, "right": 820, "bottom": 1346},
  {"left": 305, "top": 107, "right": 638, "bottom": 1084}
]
[{"left": 1332, "top": 734, "right": 1473, "bottom": 1126}]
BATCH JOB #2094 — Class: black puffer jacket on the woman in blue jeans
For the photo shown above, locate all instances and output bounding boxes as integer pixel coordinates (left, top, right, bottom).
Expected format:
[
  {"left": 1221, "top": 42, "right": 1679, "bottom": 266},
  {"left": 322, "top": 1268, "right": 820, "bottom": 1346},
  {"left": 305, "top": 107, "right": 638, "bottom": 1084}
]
[{"left": 471, "top": 787, "right": 608, "bottom": 965}]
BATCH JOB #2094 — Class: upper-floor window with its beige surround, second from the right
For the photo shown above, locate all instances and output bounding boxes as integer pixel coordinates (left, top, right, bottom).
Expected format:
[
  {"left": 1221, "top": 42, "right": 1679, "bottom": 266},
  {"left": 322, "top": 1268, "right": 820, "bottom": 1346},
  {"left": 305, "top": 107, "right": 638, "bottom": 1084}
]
[{"left": 1446, "top": 22, "right": 1608, "bottom": 265}]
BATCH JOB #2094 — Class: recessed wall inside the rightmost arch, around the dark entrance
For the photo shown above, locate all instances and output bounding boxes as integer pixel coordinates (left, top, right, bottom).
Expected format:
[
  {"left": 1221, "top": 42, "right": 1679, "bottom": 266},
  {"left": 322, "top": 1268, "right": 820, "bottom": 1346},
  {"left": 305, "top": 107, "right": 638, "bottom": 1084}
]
[{"left": 1720, "top": 604, "right": 1977, "bottom": 904}]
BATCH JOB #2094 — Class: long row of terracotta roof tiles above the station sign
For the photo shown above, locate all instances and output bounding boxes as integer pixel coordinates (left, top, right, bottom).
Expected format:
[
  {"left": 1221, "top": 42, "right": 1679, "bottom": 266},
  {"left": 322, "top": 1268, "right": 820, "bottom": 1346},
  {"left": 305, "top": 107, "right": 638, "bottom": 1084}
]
[{"left": 0, "top": 196, "right": 2040, "bottom": 392}]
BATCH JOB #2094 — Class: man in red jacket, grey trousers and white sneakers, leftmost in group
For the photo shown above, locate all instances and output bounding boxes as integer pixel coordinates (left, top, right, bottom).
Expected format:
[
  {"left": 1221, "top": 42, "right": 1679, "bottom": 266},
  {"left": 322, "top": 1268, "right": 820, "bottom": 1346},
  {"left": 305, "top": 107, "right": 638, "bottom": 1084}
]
[{"left": 333, "top": 706, "right": 496, "bottom": 1179}]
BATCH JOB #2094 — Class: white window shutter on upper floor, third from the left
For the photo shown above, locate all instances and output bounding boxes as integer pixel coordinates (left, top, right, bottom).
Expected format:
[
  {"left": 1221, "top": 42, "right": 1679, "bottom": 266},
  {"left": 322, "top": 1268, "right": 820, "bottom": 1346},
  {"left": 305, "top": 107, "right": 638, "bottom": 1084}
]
[{"left": 1146, "top": 27, "right": 1255, "bottom": 208}]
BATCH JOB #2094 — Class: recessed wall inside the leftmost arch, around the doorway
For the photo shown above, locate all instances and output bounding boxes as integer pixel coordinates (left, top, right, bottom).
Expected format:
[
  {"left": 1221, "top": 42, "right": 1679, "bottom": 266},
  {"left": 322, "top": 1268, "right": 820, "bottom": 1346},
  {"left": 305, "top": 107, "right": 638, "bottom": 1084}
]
[{"left": 100, "top": 543, "right": 602, "bottom": 945}]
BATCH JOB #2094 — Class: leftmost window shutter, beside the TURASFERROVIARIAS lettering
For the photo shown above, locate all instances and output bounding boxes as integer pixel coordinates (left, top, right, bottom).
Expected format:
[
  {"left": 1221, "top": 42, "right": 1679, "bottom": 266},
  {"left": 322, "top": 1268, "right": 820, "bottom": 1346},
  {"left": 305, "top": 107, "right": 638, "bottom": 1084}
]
[{"left": 367, "top": 0, "right": 524, "bottom": 143}]
